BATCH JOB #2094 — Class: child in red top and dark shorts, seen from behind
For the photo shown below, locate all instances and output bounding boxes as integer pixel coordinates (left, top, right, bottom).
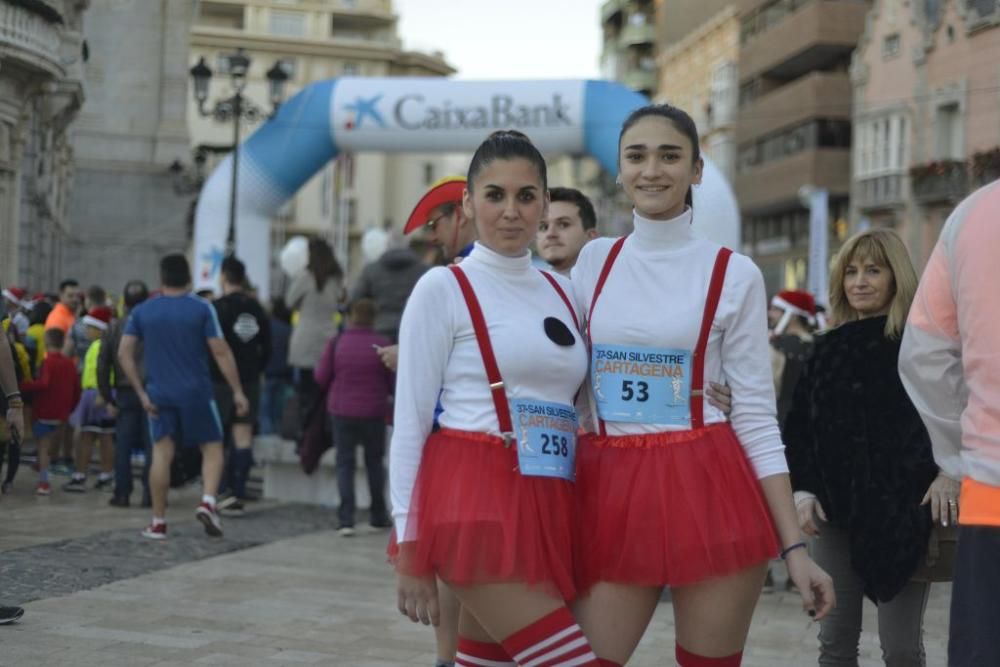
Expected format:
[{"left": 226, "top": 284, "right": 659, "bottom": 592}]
[{"left": 21, "top": 329, "right": 80, "bottom": 496}]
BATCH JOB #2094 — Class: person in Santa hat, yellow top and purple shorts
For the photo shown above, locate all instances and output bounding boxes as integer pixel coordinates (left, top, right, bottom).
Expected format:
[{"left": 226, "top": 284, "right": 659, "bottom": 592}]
[{"left": 63, "top": 306, "right": 115, "bottom": 493}]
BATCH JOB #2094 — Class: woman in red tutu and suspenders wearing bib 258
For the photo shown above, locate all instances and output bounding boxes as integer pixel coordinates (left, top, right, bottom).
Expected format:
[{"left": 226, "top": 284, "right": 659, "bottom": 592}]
[{"left": 390, "top": 132, "right": 601, "bottom": 667}]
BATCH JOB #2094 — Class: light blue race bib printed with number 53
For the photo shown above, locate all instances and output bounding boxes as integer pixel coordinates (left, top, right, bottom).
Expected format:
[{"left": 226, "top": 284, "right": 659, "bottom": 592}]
[{"left": 590, "top": 345, "right": 691, "bottom": 425}]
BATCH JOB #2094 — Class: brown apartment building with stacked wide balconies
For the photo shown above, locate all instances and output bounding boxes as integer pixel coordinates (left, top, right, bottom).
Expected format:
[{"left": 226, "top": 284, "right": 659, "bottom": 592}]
[{"left": 734, "top": 0, "right": 870, "bottom": 291}]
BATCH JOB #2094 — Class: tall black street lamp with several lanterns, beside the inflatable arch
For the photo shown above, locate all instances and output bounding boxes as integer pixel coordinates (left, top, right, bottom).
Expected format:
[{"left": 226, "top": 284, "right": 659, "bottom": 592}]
[{"left": 190, "top": 48, "right": 288, "bottom": 255}]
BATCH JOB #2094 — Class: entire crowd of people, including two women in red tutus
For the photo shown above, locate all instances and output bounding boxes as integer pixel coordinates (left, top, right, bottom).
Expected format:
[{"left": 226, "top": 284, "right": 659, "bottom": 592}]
[{"left": 2, "top": 100, "right": 1000, "bottom": 667}]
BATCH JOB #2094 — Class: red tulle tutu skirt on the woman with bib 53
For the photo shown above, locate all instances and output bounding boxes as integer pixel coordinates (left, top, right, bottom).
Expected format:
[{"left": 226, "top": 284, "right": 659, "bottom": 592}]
[{"left": 575, "top": 423, "right": 779, "bottom": 592}]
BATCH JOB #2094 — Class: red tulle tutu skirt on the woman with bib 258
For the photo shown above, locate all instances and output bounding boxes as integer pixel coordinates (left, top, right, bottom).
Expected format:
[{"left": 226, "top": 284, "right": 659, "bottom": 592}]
[{"left": 389, "top": 429, "right": 576, "bottom": 600}]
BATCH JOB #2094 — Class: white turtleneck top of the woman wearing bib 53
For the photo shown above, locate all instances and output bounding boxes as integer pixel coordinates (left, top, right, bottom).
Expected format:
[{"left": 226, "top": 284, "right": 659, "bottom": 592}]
[{"left": 572, "top": 209, "right": 788, "bottom": 478}]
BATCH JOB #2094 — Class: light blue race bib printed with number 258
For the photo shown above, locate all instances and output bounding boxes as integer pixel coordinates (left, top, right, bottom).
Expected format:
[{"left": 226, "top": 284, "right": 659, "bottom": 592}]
[{"left": 510, "top": 399, "right": 577, "bottom": 481}]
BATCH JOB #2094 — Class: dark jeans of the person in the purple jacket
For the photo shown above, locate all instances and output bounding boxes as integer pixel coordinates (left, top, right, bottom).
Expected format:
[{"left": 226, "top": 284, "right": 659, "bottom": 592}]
[{"left": 331, "top": 416, "right": 389, "bottom": 528}]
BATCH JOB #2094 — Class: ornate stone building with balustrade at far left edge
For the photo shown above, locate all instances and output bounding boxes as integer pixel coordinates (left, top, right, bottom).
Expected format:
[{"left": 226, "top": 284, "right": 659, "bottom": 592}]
[{"left": 0, "top": 0, "right": 90, "bottom": 291}]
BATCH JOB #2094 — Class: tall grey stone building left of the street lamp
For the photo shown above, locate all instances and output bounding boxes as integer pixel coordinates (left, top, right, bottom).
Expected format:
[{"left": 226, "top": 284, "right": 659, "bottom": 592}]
[{"left": 64, "top": 0, "right": 197, "bottom": 293}]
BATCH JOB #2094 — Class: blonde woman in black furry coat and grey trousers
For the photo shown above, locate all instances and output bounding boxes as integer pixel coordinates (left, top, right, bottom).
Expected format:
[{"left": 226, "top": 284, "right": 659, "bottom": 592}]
[{"left": 784, "top": 229, "right": 944, "bottom": 667}]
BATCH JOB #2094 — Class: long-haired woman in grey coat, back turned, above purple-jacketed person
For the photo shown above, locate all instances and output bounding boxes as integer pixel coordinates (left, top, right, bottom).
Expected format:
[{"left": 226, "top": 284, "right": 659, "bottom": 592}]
[{"left": 285, "top": 239, "right": 344, "bottom": 438}]
